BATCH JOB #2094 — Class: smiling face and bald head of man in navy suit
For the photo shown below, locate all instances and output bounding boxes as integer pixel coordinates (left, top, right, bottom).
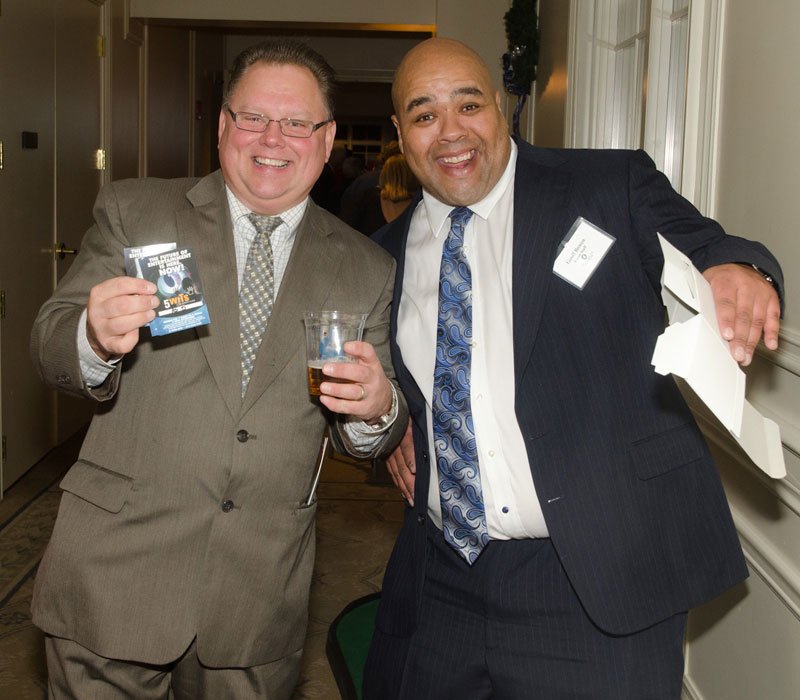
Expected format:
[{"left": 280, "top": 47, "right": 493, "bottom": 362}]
[{"left": 392, "top": 39, "right": 511, "bottom": 206}]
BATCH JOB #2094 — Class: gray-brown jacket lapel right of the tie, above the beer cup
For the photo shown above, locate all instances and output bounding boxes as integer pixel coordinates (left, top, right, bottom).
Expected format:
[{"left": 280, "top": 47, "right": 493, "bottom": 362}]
[{"left": 237, "top": 201, "right": 343, "bottom": 413}]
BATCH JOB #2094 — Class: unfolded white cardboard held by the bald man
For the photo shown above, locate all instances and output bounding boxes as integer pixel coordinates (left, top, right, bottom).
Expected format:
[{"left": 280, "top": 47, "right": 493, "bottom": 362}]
[{"left": 652, "top": 234, "right": 786, "bottom": 479}]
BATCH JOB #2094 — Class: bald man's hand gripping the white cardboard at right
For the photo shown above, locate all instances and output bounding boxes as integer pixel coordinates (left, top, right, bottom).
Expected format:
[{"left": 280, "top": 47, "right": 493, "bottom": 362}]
[{"left": 703, "top": 263, "right": 780, "bottom": 366}]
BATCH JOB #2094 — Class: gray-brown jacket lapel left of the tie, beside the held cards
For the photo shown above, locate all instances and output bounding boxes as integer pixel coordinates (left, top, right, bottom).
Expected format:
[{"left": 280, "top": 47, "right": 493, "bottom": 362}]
[{"left": 176, "top": 171, "right": 241, "bottom": 416}]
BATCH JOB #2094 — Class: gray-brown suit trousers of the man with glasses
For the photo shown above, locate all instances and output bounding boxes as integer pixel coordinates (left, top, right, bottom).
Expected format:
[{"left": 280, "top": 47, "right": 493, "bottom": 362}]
[{"left": 45, "top": 635, "right": 302, "bottom": 700}]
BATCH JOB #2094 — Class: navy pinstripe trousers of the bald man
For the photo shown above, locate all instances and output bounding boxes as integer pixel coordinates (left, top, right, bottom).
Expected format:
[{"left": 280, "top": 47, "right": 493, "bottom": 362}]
[{"left": 365, "top": 523, "right": 686, "bottom": 700}]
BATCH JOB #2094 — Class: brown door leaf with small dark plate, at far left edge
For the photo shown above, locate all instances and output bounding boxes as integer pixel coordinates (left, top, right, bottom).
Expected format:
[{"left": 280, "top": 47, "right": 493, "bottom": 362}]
[{"left": 0, "top": 0, "right": 55, "bottom": 494}]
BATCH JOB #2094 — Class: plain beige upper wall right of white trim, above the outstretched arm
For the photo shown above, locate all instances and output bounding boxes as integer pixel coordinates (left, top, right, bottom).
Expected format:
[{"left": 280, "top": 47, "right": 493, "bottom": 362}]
[{"left": 716, "top": 0, "right": 800, "bottom": 324}]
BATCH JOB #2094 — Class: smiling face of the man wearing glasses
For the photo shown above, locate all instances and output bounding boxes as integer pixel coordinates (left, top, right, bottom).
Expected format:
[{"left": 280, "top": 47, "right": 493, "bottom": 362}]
[{"left": 218, "top": 63, "right": 336, "bottom": 216}]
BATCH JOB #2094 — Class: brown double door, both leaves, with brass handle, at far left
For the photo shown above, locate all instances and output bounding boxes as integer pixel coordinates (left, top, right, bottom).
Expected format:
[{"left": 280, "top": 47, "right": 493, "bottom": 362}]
[{"left": 0, "top": 0, "right": 104, "bottom": 495}]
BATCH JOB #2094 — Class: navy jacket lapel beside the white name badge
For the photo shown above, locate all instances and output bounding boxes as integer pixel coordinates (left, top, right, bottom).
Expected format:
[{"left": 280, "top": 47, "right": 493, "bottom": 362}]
[{"left": 512, "top": 144, "right": 572, "bottom": 386}]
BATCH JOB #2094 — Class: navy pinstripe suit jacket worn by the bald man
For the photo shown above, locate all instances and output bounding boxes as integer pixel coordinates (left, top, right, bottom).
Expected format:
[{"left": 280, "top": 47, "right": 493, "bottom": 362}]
[{"left": 375, "top": 138, "right": 782, "bottom": 637}]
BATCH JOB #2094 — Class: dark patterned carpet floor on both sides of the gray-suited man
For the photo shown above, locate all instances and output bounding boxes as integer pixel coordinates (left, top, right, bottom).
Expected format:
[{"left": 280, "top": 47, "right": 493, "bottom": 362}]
[{"left": 0, "top": 435, "right": 403, "bottom": 700}]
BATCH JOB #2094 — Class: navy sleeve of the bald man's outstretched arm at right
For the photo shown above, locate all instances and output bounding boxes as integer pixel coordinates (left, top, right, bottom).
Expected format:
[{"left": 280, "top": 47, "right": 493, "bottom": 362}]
[{"left": 629, "top": 151, "right": 784, "bottom": 310}]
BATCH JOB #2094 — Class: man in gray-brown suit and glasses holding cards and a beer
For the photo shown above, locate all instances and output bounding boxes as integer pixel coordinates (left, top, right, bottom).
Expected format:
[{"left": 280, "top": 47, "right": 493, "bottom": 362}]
[{"left": 32, "top": 42, "right": 407, "bottom": 700}]
